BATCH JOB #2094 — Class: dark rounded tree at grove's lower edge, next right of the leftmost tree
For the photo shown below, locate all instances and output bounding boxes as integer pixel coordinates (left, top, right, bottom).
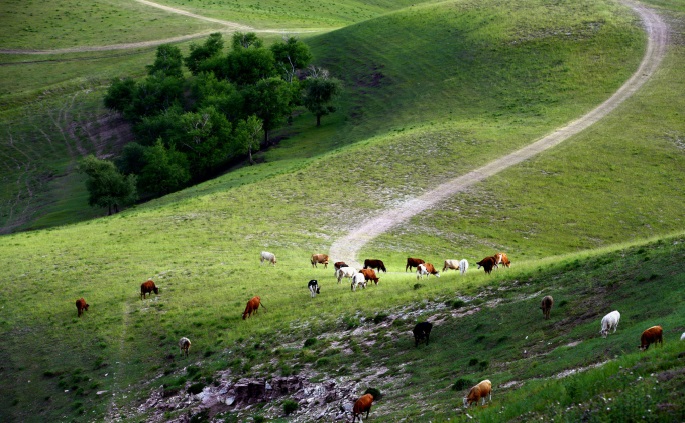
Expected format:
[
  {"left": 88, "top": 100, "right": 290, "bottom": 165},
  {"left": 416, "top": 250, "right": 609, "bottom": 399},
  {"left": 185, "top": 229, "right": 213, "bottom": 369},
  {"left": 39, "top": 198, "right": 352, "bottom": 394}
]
[{"left": 138, "top": 138, "right": 190, "bottom": 195}]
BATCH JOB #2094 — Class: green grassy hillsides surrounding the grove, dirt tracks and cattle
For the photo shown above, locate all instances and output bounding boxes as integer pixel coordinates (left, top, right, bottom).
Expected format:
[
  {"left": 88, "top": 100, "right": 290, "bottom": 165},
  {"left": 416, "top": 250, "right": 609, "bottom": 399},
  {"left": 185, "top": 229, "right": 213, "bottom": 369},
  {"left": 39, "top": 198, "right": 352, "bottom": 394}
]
[{"left": 0, "top": 0, "right": 685, "bottom": 422}]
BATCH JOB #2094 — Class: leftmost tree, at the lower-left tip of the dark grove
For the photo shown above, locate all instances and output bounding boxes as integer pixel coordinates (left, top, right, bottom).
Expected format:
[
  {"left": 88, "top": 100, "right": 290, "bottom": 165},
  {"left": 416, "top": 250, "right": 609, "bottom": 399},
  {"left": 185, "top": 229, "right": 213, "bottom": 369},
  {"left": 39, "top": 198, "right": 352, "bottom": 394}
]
[{"left": 79, "top": 155, "right": 138, "bottom": 215}]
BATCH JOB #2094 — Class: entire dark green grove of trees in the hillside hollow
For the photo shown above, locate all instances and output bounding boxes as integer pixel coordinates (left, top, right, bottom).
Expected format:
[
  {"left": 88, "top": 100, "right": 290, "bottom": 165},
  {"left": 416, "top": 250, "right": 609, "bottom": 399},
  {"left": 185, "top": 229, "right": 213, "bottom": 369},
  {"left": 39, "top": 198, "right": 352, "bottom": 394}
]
[{"left": 81, "top": 33, "right": 342, "bottom": 214}]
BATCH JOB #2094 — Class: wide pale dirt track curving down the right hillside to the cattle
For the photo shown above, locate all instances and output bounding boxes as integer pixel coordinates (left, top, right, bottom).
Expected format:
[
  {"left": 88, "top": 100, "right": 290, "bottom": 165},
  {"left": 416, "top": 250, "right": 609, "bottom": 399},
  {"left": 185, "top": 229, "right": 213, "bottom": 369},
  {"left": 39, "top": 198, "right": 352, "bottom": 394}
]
[{"left": 329, "top": 1, "right": 668, "bottom": 267}]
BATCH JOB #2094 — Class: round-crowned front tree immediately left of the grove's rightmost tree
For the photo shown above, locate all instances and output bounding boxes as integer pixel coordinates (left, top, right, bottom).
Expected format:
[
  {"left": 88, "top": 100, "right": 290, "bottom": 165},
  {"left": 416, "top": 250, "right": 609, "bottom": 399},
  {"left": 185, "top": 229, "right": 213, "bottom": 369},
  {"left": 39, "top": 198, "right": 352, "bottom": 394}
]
[{"left": 245, "top": 78, "right": 292, "bottom": 144}]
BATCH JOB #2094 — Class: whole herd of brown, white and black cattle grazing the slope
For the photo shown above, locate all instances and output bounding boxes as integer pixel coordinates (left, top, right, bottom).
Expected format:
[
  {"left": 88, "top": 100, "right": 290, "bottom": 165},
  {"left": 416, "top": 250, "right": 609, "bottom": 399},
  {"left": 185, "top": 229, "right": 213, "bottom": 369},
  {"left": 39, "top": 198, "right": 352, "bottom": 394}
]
[{"left": 76, "top": 251, "right": 685, "bottom": 422}]
